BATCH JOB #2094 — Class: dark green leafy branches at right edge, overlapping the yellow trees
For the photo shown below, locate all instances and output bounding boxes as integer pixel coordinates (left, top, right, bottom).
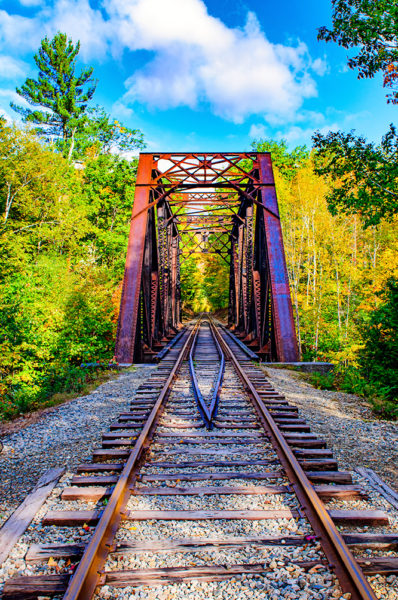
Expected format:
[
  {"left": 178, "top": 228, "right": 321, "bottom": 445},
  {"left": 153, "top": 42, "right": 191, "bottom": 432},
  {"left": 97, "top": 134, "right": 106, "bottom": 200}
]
[{"left": 313, "top": 125, "right": 398, "bottom": 227}]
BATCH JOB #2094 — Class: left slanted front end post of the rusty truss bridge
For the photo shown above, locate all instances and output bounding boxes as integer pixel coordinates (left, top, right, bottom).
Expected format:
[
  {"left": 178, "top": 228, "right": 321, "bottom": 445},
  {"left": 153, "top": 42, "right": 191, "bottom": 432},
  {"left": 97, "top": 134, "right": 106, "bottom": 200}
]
[{"left": 115, "top": 154, "right": 153, "bottom": 364}]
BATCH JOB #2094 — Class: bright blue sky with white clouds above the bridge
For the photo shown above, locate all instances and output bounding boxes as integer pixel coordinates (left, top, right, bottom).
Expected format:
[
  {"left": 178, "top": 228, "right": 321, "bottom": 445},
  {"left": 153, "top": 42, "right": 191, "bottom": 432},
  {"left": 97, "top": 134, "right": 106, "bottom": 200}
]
[{"left": 0, "top": 0, "right": 397, "bottom": 151}]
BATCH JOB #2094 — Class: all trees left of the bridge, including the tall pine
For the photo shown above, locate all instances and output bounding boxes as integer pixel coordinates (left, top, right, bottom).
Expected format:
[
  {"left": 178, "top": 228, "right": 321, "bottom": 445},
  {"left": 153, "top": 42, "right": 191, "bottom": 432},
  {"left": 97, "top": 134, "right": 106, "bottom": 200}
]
[{"left": 0, "top": 33, "right": 144, "bottom": 419}]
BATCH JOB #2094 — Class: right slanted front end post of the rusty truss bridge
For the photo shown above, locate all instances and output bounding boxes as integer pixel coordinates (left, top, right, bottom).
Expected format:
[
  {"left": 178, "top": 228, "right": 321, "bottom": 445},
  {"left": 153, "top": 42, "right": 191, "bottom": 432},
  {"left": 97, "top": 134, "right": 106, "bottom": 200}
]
[{"left": 258, "top": 154, "right": 299, "bottom": 362}]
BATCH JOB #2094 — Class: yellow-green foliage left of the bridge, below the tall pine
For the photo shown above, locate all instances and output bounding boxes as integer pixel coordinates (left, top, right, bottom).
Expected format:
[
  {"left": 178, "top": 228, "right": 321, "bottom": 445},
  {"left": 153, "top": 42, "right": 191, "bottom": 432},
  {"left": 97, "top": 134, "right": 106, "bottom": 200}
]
[{"left": 0, "top": 126, "right": 136, "bottom": 419}]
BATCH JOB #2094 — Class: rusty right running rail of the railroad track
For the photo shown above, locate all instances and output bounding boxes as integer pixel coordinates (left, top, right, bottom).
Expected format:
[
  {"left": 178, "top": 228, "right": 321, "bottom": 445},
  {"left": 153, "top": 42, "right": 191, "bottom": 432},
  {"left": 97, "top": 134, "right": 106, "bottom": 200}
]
[{"left": 209, "top": 318, "right": 376, "bottom": 600}]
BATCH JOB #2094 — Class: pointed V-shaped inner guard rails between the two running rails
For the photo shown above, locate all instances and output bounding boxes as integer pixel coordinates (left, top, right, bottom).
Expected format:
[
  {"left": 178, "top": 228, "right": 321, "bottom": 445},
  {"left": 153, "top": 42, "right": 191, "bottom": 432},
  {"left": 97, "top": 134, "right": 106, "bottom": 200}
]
[{"left": 189, "top": 317, "right": 225, "bottom": 429}]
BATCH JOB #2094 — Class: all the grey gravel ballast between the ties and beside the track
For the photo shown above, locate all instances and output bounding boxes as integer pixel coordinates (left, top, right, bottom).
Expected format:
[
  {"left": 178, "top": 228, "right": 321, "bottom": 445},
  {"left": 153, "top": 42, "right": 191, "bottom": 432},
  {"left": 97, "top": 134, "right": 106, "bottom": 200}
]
[{"left": 0, "top": 352, "right": 398, "bottom": 600}]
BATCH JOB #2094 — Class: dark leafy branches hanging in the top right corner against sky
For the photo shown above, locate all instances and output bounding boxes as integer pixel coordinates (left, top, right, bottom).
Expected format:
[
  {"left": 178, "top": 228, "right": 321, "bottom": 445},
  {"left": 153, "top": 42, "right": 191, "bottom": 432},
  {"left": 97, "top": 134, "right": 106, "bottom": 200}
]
[{"left": 318, "top": 0, "right": 398, "bottom": 104}]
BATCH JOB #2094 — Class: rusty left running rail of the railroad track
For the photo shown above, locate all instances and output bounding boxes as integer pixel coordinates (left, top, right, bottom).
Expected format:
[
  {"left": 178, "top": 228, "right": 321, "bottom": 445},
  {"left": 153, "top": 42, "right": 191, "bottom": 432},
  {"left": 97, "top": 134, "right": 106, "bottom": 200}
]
[{"left": 64, "top": 320, "right": 200, "bottom": 600}]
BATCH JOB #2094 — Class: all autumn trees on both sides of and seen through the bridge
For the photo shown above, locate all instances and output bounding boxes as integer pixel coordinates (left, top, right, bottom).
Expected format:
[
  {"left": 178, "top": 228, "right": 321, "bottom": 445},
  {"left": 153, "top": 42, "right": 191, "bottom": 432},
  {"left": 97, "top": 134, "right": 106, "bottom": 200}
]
[{"left": 0, "top": 0, "right": 398, "bottom": 418}]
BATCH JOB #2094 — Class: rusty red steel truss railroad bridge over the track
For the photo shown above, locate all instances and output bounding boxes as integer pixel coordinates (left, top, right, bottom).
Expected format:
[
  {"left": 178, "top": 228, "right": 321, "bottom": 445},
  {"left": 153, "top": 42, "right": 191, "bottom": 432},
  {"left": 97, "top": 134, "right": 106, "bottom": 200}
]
[{"left": 116, "top": 152, "right": 298, "bottom": 364}]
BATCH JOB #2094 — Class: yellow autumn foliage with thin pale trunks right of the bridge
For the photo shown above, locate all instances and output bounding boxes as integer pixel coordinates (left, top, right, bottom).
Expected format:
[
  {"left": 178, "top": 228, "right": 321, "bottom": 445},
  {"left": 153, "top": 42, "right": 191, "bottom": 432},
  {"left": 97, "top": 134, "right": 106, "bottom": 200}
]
[{"left": 275, "top": 160, "right": 398, "bottom": 362}]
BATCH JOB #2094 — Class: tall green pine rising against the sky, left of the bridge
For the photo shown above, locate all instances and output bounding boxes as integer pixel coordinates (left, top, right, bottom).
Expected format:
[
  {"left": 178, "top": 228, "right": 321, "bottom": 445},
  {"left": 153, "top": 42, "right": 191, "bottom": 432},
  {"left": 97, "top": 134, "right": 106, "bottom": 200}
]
[{"left": 11, "top": 32, "right": 97, "bottom": 158}]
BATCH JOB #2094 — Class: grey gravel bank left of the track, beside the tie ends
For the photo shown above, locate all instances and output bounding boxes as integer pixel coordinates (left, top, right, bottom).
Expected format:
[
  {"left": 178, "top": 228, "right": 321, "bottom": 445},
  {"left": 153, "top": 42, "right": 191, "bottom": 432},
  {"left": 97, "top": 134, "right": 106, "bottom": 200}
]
[{"left": 0, "top": 365, "right": 156, "bottom": 525}]
